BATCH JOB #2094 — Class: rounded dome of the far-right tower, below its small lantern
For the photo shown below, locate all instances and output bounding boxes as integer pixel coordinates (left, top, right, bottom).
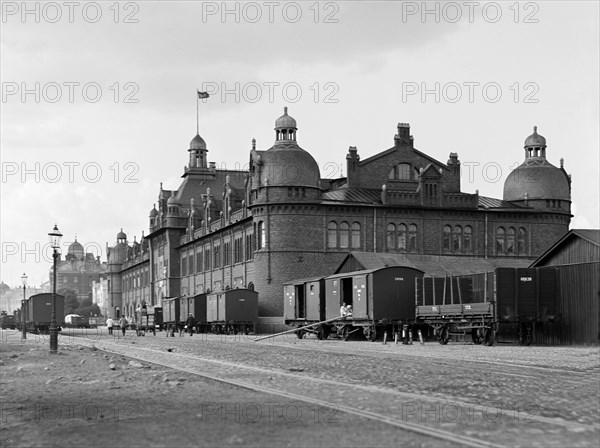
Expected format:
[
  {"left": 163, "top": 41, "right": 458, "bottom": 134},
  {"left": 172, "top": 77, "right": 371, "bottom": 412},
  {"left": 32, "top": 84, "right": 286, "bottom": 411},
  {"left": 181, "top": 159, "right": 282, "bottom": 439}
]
[{"left": 504, "top": 158, "right": 571, "bottom": 201}]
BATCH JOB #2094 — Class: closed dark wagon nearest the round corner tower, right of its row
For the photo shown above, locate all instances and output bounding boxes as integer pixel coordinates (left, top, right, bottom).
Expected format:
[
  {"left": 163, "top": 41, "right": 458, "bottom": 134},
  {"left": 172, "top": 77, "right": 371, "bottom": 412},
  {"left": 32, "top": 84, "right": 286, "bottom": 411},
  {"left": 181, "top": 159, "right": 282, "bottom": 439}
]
[{"left": 206, "top": 289, "right": 258, "bottom": 334}]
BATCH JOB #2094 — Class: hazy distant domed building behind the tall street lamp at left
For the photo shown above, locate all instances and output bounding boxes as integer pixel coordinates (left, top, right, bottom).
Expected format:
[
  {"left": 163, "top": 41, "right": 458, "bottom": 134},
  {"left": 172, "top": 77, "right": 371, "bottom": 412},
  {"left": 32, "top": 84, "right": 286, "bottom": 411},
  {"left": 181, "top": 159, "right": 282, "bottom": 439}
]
[{"left": 50, "top": 238, "right": 106, "bottom": 301}]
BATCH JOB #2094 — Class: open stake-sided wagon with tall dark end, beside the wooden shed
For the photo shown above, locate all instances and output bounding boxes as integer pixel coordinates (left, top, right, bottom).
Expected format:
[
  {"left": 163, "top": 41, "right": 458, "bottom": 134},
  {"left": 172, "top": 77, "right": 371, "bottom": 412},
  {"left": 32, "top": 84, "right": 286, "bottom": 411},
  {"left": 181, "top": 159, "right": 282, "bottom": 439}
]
[{"left": 415, "top": 268, "right": 558, "bottom": 345}]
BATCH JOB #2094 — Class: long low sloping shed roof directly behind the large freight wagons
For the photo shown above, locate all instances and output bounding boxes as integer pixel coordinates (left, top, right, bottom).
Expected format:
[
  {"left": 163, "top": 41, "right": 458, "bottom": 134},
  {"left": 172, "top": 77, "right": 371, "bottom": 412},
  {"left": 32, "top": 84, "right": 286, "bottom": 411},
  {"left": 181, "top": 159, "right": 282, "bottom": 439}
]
[{"left": 336, "top": 252, "right": 531, "bottom": 275}]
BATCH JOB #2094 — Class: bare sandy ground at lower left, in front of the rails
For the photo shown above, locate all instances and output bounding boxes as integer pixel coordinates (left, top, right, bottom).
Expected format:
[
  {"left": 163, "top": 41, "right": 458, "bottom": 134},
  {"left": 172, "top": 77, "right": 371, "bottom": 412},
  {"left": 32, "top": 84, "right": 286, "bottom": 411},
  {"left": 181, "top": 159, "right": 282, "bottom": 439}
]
[{"left": 0, "top": 332, "right": 439, "bottom": 448}]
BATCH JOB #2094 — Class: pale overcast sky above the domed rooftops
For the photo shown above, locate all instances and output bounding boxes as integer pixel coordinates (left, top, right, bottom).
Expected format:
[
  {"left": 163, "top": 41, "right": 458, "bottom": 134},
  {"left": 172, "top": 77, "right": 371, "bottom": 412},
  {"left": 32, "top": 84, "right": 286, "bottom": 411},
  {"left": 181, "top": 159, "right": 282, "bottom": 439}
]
[{"left": 0, "top": 1, "right": 600, "bottom": 286}]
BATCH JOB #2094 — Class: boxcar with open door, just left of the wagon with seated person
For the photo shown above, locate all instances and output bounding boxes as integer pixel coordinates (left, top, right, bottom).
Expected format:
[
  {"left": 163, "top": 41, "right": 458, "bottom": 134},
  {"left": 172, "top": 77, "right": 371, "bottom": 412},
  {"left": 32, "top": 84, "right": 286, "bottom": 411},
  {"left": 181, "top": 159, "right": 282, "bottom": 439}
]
[{"left": 283, "top": 277, "right": 328, "bottom": 339}]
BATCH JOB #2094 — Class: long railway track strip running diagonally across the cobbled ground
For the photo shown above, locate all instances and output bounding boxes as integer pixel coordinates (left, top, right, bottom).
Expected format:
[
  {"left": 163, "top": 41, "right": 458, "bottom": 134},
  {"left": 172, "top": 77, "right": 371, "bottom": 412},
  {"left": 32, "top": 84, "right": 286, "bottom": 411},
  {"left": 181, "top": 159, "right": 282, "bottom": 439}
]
[{"left": 67, "top": 338, "right": 597, "bottom": 447}]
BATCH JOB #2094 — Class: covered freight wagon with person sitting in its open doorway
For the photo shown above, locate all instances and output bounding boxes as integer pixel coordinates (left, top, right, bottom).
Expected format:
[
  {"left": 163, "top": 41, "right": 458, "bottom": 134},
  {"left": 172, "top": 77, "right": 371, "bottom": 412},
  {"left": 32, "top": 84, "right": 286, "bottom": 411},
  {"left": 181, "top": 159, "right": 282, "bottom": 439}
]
[{"left": 325, "top": 266, "right": 424, "bottom": 341}]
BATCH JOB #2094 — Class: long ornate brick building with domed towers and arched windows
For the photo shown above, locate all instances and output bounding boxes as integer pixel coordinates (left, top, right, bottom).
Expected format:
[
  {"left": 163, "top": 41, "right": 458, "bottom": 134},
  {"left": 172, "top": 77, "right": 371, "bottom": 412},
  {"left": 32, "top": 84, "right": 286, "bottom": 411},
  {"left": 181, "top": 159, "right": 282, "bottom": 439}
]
[{"left": 102, "top": 108, "right": 571, "bottom": 321}]
